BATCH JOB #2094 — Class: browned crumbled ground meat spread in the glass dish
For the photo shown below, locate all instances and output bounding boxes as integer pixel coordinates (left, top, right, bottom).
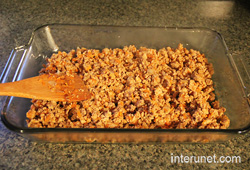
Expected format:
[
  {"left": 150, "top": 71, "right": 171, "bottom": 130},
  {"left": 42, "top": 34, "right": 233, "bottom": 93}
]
[{"left": 27, "top": 44, "right": 230, "bottom": 129}]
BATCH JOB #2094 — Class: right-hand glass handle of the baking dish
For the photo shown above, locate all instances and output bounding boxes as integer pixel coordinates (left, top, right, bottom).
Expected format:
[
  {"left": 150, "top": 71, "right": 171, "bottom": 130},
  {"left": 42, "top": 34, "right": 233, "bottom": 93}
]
[{"left": 231, "top": 52, "right": 250, "bottom": 100}]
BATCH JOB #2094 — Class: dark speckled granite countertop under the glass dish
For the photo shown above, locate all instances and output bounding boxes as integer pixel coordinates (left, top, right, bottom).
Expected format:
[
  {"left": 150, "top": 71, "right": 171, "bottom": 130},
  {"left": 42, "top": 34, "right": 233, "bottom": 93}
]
[{"left": 0, "top": 0, "right": 250, "bottom": 170}]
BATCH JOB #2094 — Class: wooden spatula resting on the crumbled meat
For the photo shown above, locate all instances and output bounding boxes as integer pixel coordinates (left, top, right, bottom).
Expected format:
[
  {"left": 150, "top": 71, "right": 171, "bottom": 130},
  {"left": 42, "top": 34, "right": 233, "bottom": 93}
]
[{"left": 0, "top": 74, "right": 91, "bottom": 101}]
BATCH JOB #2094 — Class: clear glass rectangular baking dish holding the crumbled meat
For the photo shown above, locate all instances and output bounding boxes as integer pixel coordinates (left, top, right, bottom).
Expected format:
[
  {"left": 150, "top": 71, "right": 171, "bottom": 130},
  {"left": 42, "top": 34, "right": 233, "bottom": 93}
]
[{"left": 0, "top": 24, "right": 250, "bottom": 143}]
